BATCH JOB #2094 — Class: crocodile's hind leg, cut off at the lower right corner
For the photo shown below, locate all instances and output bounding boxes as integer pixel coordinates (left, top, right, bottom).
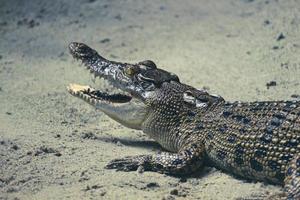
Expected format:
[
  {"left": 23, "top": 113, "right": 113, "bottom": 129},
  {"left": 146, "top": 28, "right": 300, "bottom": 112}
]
[{"left": 284, "top": 154, "right": 300, "bottom": 200}]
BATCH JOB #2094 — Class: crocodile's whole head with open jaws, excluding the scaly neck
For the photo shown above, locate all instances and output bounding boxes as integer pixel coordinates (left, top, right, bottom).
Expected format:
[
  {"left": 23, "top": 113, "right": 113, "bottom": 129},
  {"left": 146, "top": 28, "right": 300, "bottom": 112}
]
[{"left": 68, "top": 42, "right": 179, "bottom": 129}]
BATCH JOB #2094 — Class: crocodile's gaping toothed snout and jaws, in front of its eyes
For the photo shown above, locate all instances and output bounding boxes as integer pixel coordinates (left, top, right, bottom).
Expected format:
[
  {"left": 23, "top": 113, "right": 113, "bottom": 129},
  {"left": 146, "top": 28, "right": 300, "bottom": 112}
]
[{"left": 67, "top": 42, "right": 148, "bottom": 130}]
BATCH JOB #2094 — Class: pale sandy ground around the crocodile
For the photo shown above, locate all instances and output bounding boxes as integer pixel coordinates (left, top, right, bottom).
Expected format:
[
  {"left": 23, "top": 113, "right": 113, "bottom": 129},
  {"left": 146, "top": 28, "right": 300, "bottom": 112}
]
[{"left": 0, "top": 0, "right": 300, "bottom": 200}]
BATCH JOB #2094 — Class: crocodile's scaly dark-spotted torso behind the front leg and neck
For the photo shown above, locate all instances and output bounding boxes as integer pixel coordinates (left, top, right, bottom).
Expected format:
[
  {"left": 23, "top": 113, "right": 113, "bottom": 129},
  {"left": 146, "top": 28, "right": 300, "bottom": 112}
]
[{"left": 199, "top": 101, "right": 300, "bottom": 183}]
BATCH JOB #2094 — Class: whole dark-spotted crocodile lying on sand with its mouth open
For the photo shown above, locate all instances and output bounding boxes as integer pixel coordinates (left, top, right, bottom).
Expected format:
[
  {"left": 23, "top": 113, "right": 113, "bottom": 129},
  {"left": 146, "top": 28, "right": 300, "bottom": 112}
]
[{"left": 67, "top": 42, "right": 300, "bottom": 199}]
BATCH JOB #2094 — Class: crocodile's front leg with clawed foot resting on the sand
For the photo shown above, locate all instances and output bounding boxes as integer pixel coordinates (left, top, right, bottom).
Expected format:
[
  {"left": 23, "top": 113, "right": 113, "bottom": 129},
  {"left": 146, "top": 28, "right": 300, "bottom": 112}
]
[{"left": 106, "top": 144, "right": 205, "bottom": 175}]
